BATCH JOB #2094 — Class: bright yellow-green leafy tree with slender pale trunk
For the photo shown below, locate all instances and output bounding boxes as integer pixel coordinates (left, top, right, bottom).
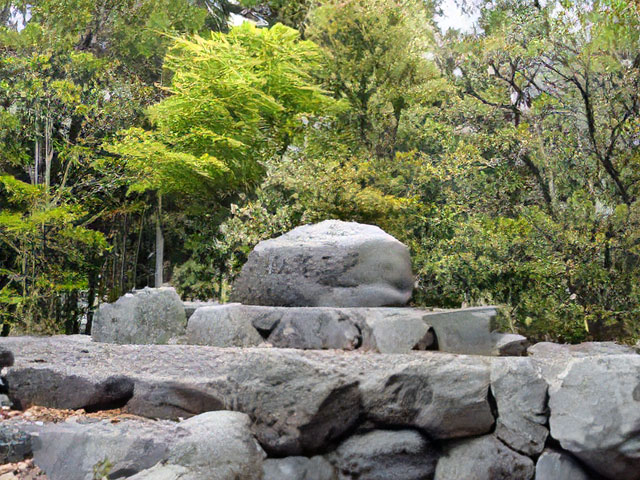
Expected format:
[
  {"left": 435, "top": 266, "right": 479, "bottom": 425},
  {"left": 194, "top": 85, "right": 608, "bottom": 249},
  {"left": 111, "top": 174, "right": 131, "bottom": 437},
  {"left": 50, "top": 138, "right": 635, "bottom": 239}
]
[{"left": 109, "top": 24, "right": 334, "bottom": 284}]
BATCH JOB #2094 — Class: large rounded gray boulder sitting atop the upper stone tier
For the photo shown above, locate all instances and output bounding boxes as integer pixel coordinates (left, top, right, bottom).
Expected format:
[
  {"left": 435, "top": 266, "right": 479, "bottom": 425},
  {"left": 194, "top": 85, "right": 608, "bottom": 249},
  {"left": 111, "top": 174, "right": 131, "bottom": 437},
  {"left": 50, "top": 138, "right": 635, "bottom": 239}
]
[{"left": 231, "top": 220, "right": 413, "bottom": 307}]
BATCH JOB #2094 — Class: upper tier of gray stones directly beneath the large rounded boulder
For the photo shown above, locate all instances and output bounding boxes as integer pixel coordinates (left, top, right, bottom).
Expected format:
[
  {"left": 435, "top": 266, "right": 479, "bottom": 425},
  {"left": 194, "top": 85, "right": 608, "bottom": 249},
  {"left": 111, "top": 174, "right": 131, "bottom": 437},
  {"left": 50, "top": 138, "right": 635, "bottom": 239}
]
[{"left": 92, "top": 288, "right": 527, "bottom": 355}]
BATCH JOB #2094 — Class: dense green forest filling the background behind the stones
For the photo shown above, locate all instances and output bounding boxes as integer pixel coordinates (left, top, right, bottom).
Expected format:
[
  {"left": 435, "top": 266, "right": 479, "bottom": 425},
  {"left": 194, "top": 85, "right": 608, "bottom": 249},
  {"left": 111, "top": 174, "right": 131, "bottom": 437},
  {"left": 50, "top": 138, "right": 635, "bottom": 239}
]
[{"left": 0, "top": 0, "right": 640, "bottom": 342}]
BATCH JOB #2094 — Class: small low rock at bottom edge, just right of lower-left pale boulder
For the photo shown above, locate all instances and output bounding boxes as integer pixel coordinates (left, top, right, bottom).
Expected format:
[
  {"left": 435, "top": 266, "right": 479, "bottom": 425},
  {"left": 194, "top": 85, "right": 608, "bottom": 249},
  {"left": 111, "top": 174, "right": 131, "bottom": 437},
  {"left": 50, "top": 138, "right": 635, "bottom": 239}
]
[{"left": 262, "top": 456, "right": 338, "bottom": 480}]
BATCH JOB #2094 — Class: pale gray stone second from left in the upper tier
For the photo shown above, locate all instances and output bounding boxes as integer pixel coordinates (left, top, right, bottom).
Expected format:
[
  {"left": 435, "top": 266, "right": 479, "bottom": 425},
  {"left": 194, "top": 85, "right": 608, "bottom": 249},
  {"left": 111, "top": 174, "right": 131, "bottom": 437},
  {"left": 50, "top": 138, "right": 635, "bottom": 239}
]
[{"left": 186, "top": 304, "right": 262, "bottom": 347}]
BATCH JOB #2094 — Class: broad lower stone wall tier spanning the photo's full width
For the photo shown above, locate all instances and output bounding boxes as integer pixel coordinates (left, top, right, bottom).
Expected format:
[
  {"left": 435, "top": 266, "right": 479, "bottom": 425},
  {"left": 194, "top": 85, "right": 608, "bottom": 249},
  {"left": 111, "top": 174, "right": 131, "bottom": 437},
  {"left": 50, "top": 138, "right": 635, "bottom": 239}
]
[{"left": 0, "top": 336, "right": 640, "bottom": 480}]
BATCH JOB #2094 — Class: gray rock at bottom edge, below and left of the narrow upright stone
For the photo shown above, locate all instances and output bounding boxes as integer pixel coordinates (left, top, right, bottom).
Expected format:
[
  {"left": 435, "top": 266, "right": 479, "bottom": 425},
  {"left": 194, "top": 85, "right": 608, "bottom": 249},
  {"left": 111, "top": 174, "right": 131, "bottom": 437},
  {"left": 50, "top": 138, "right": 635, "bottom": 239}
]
[{"left": 434, "top": 435, "right": 534, "bottom": 480}]
